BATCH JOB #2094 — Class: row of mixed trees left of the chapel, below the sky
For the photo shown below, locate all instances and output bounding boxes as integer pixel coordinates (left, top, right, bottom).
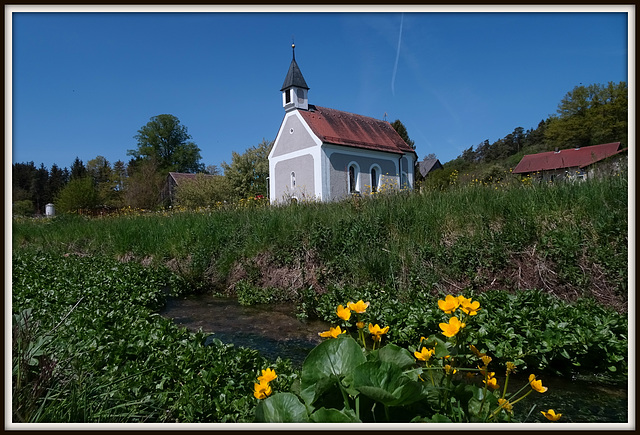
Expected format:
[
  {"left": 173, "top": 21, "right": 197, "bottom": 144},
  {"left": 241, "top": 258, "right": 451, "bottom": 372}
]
[{"left": 12, "top": 114, "right": 273, "bottom": 216}]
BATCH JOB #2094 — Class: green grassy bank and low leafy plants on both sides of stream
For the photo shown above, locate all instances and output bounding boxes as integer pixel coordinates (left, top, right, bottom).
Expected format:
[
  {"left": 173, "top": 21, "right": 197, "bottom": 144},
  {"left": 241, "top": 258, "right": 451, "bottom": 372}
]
[{"left": 12, "top": 177, "right": 628, "bottom": 422}]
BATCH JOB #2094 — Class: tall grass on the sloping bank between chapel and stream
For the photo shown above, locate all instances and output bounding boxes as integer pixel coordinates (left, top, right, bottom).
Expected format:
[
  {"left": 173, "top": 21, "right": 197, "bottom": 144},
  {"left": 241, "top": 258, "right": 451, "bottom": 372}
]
[{"left": 13, "top": 176, "right": 628, "bottom": 306}]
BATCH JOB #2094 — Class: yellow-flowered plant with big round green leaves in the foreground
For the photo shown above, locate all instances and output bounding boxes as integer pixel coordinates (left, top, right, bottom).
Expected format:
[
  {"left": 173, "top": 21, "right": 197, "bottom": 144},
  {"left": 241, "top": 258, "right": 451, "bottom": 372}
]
[{"left": 254, "top": 295, "right": 562, "bottom": 423}]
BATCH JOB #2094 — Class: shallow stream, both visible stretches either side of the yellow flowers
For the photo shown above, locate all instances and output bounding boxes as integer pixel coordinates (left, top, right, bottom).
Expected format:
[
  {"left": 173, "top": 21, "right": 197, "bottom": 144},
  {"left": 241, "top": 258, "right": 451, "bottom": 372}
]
[{"left": 160, "top": 294, "right": 629, "bottom": 423}]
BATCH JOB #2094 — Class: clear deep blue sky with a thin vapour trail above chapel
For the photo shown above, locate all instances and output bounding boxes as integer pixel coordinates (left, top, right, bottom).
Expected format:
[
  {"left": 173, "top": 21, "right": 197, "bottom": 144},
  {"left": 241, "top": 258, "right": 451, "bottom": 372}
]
[{"left": 7, "top": 6, "right": 635, "bottom": 174}]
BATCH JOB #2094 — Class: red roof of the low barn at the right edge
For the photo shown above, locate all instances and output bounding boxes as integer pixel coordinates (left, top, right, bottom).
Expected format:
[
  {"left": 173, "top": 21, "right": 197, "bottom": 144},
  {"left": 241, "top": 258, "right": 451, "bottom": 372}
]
[{"left": 513, "top": 142, "right": 620, "bottom": 174}]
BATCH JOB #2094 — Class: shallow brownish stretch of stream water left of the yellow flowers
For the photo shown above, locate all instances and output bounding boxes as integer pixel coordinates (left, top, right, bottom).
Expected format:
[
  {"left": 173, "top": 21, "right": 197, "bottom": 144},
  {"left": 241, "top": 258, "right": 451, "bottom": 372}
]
[{"left": 160, "top": 295, "right": 329, "bottom": 367}]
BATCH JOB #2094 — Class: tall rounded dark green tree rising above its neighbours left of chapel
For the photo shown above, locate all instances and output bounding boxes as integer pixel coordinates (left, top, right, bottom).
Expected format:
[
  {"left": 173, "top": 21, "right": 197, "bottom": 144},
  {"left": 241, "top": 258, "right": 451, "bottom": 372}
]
[{"left": 127, "top": 115, "right": 204, "bottom": 173}]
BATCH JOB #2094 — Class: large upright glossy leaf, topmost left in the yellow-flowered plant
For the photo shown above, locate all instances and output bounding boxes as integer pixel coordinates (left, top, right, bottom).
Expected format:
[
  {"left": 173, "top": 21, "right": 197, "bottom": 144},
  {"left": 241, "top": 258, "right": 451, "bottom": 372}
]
[{"left": 301, "top": 336, "right": 366, "bottom": 404}]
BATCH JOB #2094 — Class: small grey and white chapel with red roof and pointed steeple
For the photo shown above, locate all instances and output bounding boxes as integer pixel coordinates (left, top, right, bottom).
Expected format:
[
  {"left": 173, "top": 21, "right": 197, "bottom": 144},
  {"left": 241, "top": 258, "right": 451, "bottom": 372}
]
[{"left": 269, "top": 46, "right": 417, "bottom": 203}]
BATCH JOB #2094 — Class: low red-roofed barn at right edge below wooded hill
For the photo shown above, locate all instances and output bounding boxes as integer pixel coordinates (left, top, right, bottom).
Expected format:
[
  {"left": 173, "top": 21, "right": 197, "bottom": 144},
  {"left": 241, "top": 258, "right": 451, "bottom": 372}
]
[{"left": 513, "top": 142, "right": 627, "bottom": 181}]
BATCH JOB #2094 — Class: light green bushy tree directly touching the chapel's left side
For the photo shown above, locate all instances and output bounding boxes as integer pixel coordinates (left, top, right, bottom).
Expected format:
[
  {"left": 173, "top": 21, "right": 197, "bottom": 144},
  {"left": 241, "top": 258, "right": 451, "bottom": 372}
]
[{"left": 221, "top": 139, "right": 273, "bottom": 198}]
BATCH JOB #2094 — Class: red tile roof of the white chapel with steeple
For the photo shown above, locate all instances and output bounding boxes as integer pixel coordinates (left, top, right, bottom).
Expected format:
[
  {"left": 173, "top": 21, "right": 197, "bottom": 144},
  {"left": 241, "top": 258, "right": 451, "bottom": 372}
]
[{"left": 299, "top": 104, "right": 415, "bottom": 154}]
